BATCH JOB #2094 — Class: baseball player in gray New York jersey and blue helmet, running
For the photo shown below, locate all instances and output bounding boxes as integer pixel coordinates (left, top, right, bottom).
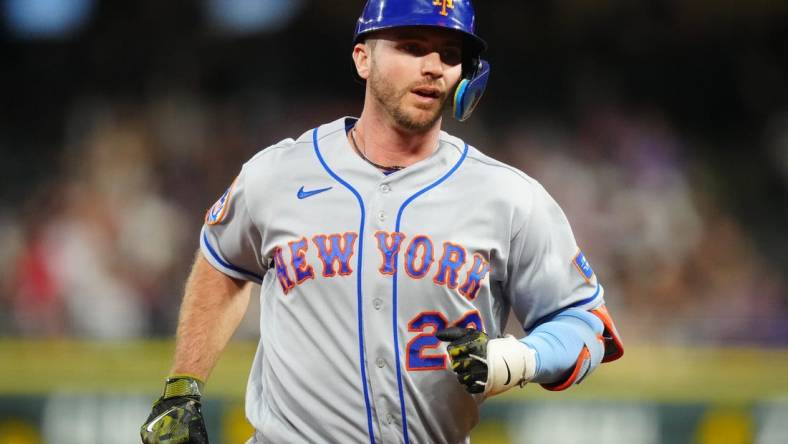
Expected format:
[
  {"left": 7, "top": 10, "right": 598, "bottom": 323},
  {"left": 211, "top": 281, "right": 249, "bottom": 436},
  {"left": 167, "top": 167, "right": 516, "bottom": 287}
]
[{"left": 141, "top": 0, "right": 623, "bottom": 443}]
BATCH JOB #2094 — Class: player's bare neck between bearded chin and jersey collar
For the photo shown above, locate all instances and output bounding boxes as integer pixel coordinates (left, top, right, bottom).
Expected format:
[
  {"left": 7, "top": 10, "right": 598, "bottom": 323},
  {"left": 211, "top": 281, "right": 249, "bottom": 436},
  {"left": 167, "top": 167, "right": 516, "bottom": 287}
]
[{"left": 351, "top": 113, "right": 441, "bottom": 167}]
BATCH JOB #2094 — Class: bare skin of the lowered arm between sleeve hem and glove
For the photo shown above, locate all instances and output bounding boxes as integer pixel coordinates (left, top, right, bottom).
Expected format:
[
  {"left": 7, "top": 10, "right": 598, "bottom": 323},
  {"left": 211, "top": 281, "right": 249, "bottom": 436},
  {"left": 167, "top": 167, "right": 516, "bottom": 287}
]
[{"left": 170, "top": 252, "right": 249, "bottom": 381}]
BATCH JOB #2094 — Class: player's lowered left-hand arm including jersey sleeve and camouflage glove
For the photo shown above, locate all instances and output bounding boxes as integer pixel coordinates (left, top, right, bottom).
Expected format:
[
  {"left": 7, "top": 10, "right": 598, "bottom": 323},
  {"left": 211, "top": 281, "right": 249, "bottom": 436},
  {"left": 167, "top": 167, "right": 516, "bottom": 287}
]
[{"left": 141, "top": 162, "right": 267, "bottom": 444}]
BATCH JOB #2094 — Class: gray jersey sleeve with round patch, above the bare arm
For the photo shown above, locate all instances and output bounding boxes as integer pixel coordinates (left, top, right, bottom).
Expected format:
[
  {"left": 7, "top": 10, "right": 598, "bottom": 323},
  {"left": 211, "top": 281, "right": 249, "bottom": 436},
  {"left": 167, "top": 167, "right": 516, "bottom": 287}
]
[{"left": 200, "top": 164, "right": 267, "bottom": 283}]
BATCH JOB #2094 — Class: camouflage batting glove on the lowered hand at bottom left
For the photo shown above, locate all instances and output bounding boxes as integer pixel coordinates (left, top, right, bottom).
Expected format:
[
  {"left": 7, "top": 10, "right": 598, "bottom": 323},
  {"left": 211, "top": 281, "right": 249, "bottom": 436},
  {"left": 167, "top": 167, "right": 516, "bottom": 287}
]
[{"left": 140, "top": 376, "right": 208, "bottom": 444}]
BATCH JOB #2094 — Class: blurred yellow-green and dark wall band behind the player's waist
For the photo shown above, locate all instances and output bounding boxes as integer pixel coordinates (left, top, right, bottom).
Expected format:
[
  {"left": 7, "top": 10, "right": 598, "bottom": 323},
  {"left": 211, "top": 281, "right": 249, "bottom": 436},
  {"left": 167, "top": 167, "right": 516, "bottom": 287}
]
[{"left": 0, "top": 339, "right": 788, "bottom": 444}]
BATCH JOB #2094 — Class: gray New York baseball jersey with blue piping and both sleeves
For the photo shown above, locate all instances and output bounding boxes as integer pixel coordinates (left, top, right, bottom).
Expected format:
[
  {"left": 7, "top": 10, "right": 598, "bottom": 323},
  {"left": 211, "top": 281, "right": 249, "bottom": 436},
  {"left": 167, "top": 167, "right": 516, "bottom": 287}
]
[{"left": 201, "top": 118, "right": 603, "bottom": 443}]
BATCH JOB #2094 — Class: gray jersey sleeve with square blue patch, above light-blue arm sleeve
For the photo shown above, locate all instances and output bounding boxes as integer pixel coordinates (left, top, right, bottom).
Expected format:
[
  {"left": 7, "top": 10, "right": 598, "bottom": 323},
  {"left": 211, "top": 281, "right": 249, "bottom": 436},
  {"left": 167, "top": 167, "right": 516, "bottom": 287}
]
[{"left": 505, "top": 183, "right": 603, "bottom": 332}]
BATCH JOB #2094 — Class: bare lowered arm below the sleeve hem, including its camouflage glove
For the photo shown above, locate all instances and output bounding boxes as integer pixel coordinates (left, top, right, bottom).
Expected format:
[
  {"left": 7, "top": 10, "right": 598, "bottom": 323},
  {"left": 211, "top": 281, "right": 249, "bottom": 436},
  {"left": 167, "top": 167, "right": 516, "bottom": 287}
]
[{"left": 140, "top": 252, "right": 249, "bottom": 444}]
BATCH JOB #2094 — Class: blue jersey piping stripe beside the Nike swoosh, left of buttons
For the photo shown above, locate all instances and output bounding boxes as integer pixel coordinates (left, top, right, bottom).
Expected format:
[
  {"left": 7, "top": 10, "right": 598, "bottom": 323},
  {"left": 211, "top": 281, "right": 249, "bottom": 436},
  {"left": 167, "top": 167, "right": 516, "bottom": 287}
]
[{"left": 312, "top": 128, "right": 375, "bottom": 444}]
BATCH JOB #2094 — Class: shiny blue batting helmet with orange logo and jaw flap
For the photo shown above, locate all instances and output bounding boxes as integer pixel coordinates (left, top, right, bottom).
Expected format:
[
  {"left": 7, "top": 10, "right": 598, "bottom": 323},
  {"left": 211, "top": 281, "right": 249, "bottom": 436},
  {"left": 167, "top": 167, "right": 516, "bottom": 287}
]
[{"left": 353, "top": 0, "right": 490, "bottom": 121}]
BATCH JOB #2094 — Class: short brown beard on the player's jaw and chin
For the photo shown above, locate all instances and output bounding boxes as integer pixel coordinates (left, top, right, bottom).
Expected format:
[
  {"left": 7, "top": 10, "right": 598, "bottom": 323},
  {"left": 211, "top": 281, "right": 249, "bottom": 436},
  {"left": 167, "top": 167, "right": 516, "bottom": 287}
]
[{"left": 367, "top": 64, "right": 446, "bottom": 133}]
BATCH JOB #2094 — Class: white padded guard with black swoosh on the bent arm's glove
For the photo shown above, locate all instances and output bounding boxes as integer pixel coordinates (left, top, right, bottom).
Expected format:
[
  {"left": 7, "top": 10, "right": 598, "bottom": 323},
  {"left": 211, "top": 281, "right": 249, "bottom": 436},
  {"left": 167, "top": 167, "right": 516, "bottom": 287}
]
[{"left": 483, "top": 335, "right": 536, "bottom": 396}]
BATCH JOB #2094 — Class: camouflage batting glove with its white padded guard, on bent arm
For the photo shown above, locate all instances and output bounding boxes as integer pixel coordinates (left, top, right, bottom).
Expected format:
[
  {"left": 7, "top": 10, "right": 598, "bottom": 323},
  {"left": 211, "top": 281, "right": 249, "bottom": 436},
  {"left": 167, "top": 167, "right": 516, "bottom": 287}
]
[{"left": 435, "top": 327, "right": 536, "bottom": 396}]
